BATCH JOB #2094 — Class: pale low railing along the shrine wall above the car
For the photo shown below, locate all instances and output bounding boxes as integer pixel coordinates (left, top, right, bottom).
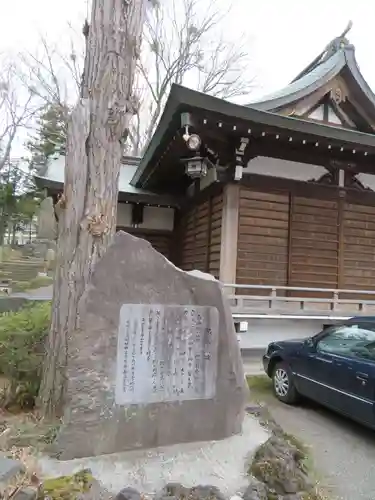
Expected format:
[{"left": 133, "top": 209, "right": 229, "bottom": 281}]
[{"left": 224, "top": 284, "right": 375, "bottom": 318}]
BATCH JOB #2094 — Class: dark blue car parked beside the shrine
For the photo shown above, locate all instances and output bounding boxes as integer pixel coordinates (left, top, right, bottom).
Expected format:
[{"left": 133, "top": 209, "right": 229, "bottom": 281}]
[{"left": 263, "top": 317, "right": 375, "bottom": 428}]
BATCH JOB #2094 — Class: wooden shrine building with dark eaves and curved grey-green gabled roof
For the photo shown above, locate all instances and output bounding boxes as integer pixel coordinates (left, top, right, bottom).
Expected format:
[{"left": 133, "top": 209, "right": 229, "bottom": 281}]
[{"left": 37, "top": 33, "right": 375, "bottom": 300}]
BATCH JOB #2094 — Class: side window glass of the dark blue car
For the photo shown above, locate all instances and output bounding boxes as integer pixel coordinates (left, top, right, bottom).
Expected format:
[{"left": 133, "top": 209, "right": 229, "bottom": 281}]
[{"left": 317, "top": 324, "right": 375, "bottom": 361}]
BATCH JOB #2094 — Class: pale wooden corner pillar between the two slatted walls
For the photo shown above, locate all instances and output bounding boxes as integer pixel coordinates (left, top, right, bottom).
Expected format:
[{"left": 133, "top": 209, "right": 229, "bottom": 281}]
[{"left": 220, "top": 184, "right": 240, "bottom": 286}]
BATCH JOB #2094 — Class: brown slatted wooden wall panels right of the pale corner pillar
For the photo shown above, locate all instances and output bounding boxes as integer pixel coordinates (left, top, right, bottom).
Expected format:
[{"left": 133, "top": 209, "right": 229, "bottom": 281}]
[{"left": 237, "top": 186, "right": 375, "bottom": 290}]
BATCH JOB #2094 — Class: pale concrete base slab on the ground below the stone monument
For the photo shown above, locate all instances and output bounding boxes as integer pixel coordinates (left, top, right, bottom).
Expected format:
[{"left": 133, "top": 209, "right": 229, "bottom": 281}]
[{"left": 39, "top": 415, "right": 269, "bottom": 498}]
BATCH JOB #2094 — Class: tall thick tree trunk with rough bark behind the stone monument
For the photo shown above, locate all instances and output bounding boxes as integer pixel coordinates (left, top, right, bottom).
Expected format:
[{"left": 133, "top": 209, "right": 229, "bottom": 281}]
[{"left": 39, "top": 0, "right": 149, "bottom": 417}]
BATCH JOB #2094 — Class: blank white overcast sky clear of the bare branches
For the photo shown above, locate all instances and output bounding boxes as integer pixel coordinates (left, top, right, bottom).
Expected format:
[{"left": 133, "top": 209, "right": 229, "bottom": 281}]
[{"left": 0, "top": 0, "right": 375, "bottom": 98}]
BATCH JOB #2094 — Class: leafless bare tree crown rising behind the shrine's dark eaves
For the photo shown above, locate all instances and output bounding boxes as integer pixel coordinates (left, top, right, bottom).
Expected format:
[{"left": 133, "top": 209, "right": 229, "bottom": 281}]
[{"left": 129, "top": 0, "right": 252, "bottom": 154}]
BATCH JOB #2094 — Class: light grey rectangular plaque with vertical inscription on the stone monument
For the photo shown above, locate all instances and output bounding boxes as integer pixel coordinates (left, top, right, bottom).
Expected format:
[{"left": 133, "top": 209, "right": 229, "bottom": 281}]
[{"left": 115, "top": 304, "right": 219, "bottom": 405}]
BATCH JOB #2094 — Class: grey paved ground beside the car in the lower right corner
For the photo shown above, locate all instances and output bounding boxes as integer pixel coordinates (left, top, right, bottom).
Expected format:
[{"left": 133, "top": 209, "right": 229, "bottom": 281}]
[{"left": 267, "top": 398, "right": 375, "bottom": 500}]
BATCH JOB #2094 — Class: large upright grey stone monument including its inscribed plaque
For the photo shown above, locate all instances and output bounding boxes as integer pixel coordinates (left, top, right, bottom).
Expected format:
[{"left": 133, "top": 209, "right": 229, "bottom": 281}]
[{"left": 54, "top": 232, "right": 247, "bottom": 460}]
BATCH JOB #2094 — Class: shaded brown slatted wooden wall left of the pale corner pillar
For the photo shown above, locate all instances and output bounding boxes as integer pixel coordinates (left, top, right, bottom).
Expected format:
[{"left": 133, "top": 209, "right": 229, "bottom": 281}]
[{"left": 176, "top": 190, "right": 223, "bottom": 278}]
